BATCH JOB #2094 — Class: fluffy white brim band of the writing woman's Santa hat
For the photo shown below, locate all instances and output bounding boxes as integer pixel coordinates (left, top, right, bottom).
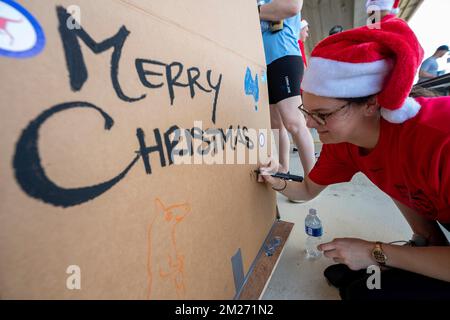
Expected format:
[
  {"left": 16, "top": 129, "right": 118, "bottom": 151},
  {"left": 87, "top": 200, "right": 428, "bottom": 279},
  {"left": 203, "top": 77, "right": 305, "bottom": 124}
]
[{"left": 302, "top": 57, "right": 392, "bottom": 98}]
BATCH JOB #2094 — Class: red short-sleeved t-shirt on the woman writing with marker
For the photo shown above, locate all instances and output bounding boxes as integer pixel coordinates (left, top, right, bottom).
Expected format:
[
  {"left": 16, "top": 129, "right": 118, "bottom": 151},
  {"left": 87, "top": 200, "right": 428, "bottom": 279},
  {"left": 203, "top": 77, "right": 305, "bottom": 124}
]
[{"left": 309, "top": 97, "right": 450, "bottom": 223}]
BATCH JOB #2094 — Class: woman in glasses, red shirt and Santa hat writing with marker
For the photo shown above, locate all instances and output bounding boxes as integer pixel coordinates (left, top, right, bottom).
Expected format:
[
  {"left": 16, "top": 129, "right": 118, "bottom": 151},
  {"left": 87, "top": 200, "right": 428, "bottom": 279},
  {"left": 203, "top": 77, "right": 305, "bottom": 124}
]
[{"left": 260, "top": 15, "right": 450, "bottom": 299}]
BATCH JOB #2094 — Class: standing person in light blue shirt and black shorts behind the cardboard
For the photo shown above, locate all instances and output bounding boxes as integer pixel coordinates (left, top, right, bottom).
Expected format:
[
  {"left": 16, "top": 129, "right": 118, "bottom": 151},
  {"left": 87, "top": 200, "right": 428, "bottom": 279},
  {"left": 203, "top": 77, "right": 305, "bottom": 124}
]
[{"left": 258, "top": 0, "right": 315, "bottom": 176}]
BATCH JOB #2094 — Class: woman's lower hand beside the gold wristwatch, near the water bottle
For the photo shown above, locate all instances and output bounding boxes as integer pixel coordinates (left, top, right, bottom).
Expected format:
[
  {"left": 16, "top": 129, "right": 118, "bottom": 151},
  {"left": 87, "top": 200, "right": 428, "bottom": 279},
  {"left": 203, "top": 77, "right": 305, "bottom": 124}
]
[{"left": 318, "top": 238, "right": 377, "bottom": 271}]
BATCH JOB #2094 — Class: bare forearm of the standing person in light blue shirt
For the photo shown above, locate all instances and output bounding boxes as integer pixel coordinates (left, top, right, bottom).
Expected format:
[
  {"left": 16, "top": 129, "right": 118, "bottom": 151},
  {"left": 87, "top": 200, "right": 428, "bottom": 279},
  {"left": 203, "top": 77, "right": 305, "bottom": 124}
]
[{"left": 259, "top": 0, "right": 303, "bottom": 21}]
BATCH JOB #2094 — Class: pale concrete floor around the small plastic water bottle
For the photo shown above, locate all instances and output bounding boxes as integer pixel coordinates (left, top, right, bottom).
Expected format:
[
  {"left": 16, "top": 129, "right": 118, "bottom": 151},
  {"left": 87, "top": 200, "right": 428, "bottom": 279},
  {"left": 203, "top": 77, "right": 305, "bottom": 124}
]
[{"left": 262, "top": 135, "right": 412, "bottom": 300}]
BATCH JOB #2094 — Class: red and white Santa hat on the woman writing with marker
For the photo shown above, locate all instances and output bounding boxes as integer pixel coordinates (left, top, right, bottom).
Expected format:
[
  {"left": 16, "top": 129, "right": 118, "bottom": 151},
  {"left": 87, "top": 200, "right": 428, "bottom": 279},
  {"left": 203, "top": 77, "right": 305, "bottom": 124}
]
[{"left": 302, "top": 15, "right": 423, "bottom": 123}]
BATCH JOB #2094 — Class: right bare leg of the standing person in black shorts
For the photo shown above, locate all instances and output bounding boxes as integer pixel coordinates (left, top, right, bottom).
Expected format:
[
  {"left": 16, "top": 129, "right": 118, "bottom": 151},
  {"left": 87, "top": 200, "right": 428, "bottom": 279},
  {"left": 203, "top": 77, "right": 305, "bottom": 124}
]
[{"left": 276, "top": 96, "right": 315, "bottom": 177}]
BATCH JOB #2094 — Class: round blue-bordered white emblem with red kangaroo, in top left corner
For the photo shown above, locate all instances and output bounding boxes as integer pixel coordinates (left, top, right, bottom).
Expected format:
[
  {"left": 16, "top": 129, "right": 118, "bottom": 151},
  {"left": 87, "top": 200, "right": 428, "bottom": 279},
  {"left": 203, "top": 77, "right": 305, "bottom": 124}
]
[{"left": 0, "top": 0, "right": 45, "bottom": 58}]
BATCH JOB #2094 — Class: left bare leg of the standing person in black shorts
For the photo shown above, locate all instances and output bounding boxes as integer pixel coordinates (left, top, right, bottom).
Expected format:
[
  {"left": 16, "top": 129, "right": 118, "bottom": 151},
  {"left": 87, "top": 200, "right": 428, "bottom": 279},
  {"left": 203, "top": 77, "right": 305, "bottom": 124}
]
[{"left": 270, "top": 104, "right": 290, "bottom": 173}]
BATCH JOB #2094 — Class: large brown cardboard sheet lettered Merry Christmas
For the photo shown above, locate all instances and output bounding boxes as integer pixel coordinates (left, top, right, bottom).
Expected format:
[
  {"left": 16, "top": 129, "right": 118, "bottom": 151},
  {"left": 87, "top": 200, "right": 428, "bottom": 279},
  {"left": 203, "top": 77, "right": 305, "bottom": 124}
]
[{"left": 0, "top": 0, "right": 275, "bottom": 299}]
